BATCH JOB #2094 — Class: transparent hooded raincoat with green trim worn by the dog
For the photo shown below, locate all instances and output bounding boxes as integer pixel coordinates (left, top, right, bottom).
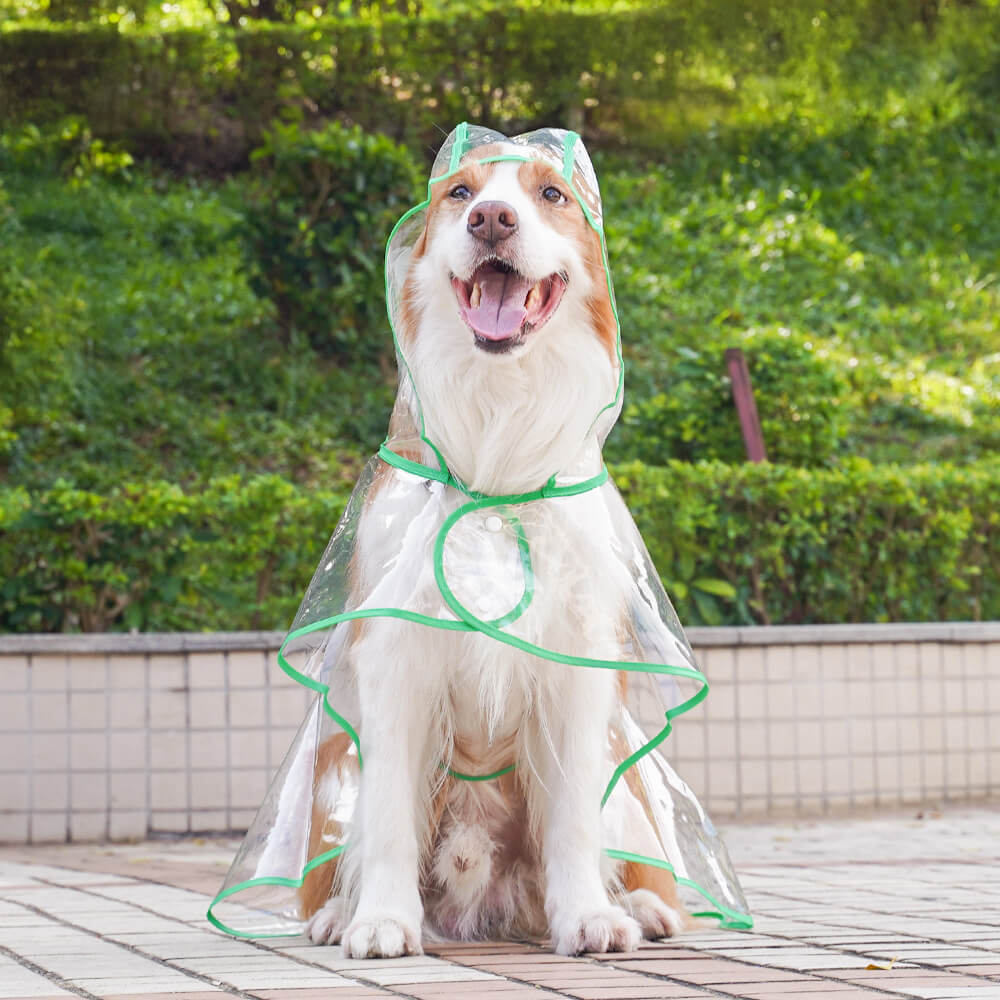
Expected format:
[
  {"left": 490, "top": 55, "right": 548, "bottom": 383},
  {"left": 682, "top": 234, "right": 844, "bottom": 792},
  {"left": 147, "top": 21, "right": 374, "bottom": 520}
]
[{"left": 208, "top": 124, "right": 752, "bottom": 937}]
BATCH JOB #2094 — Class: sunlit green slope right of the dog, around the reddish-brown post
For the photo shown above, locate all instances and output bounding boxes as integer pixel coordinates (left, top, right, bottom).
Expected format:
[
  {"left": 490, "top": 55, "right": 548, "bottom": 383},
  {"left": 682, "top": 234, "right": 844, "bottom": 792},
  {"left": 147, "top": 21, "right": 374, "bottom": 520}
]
[{"left": 601, "top": 22, "right": 1000, "bottom": 464}]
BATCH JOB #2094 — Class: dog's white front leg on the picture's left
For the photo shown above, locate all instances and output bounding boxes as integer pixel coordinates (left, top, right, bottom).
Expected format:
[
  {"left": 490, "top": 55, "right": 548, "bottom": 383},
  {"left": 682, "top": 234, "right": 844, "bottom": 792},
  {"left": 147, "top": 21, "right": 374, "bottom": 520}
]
[{"left": 342, "top": 622, "right": 434, "bottom": 958}]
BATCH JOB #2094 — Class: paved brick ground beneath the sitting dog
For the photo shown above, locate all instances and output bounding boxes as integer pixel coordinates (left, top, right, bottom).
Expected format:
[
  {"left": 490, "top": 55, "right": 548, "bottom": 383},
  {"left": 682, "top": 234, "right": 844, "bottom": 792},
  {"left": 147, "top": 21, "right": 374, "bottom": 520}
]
[{"left": 0, "top": 804, "right": 1000, "bottom": 1000}]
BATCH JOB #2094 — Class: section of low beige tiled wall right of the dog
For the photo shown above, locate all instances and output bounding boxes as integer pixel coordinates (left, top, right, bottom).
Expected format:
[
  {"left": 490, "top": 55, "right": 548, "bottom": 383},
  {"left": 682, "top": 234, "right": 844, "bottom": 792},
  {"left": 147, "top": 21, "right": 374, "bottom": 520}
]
[{"left": 670, "top": 625, "right": 1000, "bottom": 816}]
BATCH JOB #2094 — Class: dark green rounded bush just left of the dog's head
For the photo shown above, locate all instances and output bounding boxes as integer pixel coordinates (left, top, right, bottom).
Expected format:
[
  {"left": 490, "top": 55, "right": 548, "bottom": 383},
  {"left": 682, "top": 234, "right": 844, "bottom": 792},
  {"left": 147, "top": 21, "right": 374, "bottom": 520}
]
[{"left": 237, "top": 123, "right": 418, "bottom": 360}]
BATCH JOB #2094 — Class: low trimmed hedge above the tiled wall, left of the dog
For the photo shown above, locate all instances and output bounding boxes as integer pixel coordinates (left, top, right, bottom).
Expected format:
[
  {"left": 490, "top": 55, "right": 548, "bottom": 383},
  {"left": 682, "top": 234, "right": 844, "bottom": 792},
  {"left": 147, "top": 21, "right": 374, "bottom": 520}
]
[{"left": 0, "top": 476, "right": 346, "bottom": 632}]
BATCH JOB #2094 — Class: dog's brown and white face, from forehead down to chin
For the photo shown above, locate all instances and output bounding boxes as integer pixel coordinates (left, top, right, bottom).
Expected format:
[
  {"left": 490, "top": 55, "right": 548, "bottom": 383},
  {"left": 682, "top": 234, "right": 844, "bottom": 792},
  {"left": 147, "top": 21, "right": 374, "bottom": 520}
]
[{"left": 399, "top": 133, "right": 617, "bottom": 360}]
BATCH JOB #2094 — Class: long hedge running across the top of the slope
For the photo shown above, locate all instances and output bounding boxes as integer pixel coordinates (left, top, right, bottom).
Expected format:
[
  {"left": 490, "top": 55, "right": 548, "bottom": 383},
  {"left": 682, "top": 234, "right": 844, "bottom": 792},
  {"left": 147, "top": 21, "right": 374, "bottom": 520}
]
[{"left": 0, "top": 0, "right": 952, "bottom": 169}]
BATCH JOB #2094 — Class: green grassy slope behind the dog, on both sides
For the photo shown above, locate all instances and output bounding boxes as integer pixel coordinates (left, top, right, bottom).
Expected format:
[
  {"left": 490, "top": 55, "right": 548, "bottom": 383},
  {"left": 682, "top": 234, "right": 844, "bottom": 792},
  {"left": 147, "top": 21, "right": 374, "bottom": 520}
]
[{"left": 0, "top": 3, "right": 1000, "bottom": 486}]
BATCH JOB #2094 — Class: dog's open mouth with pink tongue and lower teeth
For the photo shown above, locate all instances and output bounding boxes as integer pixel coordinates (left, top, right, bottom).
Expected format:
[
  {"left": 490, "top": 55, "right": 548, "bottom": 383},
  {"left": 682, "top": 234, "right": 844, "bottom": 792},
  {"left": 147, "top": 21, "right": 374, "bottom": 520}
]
[{"left": 451, "top": 260, "right": 566, "bottom": 354}]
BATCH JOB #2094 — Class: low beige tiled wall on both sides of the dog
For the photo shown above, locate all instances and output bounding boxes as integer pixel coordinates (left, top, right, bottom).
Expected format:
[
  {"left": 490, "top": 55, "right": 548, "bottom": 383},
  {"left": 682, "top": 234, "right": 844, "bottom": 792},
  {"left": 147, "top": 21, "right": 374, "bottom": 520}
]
[{"left": 0, "top": 623, "right": 1000, "bottom": 842}]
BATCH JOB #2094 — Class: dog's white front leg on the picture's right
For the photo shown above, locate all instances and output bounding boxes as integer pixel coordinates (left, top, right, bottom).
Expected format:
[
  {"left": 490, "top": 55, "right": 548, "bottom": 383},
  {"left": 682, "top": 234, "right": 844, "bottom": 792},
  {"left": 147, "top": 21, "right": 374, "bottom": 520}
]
[{"left": 540, "top": 667, "right": 642, "bottom": 955}]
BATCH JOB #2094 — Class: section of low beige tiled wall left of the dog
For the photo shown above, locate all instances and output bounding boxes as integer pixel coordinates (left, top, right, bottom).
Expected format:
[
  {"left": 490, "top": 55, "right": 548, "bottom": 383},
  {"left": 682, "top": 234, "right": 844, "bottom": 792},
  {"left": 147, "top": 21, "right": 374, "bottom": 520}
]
[{"left": 0, "top": 636, "right": 310, "bottom": 842}]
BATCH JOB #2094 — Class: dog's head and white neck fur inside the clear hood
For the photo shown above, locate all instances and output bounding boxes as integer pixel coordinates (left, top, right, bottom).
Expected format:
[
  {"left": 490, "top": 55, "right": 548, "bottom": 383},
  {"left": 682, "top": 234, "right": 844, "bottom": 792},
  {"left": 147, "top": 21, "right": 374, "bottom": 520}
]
[{"left": 386, "top": 128, "right": 621, "bottom": 491}]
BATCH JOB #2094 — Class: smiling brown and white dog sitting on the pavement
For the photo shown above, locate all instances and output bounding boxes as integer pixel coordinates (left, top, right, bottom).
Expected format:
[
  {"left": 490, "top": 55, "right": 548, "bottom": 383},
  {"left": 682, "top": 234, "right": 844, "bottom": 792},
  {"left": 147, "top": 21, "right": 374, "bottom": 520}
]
[{"left": 300, "top": 145, "right": 686, "bottom": 958}]
